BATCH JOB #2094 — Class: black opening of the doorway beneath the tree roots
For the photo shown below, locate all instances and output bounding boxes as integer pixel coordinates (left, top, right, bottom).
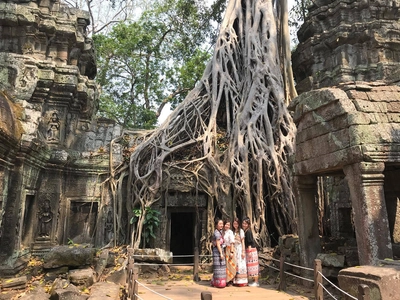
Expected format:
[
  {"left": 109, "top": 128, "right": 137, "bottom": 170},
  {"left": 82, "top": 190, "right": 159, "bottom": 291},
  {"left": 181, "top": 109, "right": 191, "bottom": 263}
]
[{"left": 170, "top": 212, "right": 195, "bottom": 264}]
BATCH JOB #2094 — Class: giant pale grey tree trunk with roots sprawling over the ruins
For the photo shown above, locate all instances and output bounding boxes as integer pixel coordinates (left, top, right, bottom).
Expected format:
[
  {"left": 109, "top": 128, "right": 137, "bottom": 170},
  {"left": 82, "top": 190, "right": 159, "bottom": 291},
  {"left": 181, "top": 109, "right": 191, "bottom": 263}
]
[{"left": 128, "top": 0, "right": 296, "bottom": 247}]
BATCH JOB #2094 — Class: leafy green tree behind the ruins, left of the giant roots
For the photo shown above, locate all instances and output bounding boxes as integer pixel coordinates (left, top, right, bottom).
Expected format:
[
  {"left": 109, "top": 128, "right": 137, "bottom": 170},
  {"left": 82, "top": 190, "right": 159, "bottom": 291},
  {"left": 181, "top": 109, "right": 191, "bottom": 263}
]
[{"left": 93, "top": 0, "right": 225, "bottom": 129}]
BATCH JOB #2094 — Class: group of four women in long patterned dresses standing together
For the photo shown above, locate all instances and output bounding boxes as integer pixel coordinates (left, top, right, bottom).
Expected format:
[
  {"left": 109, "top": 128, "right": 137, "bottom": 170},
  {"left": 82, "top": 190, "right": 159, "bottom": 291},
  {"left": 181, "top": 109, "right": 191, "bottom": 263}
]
[{"left": 211, "top": 217, "right": 259, "bottom": 288}]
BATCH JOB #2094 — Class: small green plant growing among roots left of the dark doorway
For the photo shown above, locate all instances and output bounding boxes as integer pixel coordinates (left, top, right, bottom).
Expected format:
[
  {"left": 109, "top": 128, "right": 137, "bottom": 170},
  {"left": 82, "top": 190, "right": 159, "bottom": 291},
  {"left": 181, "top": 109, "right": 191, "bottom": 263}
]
[{"left": 130, "top": 207, "right": 161, "bottom": 247}]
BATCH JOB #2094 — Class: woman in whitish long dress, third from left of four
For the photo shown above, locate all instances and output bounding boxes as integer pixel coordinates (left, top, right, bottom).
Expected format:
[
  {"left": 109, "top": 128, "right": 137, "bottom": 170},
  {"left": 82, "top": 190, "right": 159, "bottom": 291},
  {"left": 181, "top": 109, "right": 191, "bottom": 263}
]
[{"left": 232, "top": 218, "right": 248, "bottom": 286}]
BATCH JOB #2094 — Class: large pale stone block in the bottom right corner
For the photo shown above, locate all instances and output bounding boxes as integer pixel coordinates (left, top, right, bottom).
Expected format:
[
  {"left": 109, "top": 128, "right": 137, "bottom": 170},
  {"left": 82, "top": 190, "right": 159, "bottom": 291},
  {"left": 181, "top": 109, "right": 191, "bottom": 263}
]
[{"left": 338, "top": 266, "right": 400, "bottom": 300}]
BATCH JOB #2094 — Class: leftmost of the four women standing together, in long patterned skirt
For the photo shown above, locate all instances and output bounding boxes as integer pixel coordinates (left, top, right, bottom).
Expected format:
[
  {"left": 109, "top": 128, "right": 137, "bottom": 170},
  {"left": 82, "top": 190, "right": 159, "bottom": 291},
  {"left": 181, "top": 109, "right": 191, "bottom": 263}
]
[{"left": 211, "top": 219, "right": 226, "bottom": 288}]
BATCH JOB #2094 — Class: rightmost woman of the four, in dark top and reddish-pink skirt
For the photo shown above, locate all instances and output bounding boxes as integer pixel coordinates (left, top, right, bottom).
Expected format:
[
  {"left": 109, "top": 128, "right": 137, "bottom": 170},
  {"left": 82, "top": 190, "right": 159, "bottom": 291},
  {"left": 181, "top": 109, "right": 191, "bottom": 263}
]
[{"left": 242, "top": 217, "right": 260, "bottom": 286}]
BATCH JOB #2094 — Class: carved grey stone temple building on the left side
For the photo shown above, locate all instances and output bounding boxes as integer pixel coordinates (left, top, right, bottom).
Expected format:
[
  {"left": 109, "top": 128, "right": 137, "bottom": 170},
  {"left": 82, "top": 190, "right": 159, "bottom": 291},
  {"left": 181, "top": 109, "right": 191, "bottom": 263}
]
[{"left": 0, "top": 0, "right": 121, "bottom": 273}]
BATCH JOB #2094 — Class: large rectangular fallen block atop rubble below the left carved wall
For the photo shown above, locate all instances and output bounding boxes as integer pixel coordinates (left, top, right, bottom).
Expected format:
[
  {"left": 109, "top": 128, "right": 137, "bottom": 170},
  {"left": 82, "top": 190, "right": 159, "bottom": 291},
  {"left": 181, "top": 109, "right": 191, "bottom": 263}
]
[{"left": 43, "top": 246, "right": 96, "bottom": 269}]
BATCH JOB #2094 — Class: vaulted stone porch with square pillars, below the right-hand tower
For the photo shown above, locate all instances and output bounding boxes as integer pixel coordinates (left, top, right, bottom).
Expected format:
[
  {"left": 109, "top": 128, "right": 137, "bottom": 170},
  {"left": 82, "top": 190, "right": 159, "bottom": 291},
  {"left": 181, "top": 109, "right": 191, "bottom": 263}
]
[{"left": 289, "top": 84, "right": 400, "bottom": 267}]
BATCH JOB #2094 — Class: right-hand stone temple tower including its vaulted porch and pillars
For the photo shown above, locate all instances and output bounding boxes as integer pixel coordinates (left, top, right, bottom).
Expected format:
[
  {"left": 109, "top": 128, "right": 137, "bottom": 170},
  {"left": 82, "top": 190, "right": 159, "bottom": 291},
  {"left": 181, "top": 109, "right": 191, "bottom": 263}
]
[{"left": 291, "top": 0, "right": 400, "bottom": 266}]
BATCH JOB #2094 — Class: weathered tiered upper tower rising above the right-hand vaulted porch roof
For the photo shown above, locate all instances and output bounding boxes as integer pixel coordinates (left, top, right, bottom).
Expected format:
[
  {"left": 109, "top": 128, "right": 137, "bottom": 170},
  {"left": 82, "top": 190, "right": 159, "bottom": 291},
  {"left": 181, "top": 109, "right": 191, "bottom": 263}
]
[{"left": 293, "top": 0, "right": 400, "bottom": 92}]
